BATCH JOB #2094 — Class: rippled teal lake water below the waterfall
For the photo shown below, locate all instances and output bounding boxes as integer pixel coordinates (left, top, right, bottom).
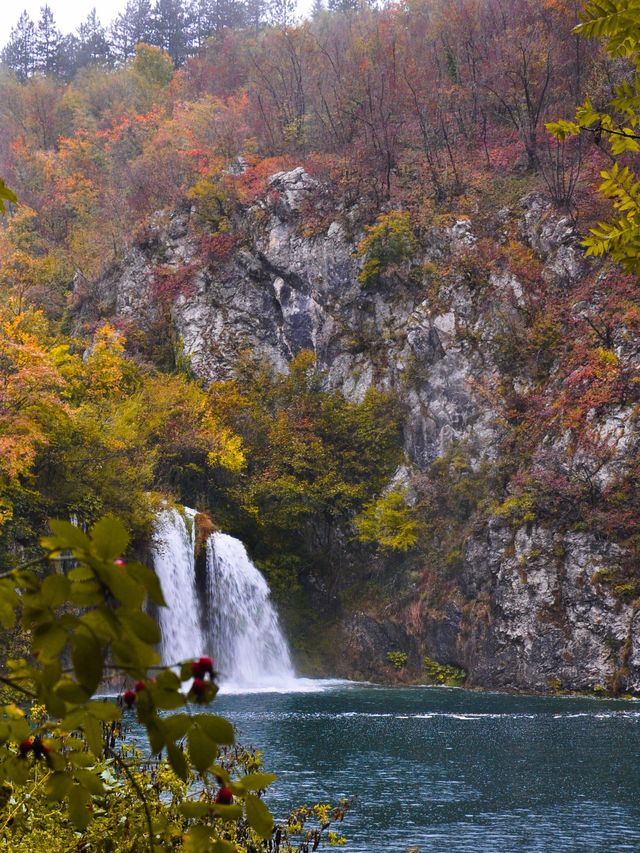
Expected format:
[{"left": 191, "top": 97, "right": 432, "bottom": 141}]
[{"left": 213, "top": 684, "right": 640, "bottom": 853}]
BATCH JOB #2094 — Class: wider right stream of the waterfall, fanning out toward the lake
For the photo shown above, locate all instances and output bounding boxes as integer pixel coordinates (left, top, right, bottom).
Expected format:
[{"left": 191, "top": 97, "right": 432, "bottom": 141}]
[{"left": 207, "top": 533, "right": 295, "bottom": 690}]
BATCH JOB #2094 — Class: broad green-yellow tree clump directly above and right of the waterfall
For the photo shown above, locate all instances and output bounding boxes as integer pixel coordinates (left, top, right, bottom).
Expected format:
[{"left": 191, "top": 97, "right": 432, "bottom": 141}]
[{"left": 209, "top": 352, "right": 402, "bottom": 546}]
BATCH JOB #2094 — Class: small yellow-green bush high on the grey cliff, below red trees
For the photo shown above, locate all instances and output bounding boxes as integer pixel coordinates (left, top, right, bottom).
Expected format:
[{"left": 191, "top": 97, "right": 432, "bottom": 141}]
[{"left": 356, "top": 210, "right": 418, "bottom": 286}]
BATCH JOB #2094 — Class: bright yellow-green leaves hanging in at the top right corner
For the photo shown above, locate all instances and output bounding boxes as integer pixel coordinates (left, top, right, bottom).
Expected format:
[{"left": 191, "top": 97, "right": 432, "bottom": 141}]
[{"left": 547, "top": 0, "right": 640, "bottom": 274}]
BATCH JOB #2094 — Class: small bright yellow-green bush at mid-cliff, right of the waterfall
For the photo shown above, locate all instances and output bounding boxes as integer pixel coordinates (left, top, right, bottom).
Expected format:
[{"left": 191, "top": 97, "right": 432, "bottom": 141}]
[{"left": 354, "top": 489, "right": 420, "bottom": 551}]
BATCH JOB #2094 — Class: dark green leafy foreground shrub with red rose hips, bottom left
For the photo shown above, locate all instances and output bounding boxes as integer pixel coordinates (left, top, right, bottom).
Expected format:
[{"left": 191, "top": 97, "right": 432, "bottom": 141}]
[{"left": 0, "top": 516, "right": 350, "bottom": 853}]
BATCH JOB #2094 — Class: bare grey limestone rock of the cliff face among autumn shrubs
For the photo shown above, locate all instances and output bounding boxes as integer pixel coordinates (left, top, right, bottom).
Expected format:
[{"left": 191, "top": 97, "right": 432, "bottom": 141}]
[{"left": 98, "top": 168, "right": 640, "bottom": 690}]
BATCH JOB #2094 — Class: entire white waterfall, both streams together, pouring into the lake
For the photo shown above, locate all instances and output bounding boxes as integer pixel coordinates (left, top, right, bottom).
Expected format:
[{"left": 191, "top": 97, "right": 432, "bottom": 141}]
[{"left": 151, "top": 507, "right": 340, "bottom": 693}]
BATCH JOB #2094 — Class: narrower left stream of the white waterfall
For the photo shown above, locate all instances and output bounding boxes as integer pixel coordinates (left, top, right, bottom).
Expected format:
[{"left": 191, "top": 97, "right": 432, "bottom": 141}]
[{"left": 151, "top": 507, "right": 206, "bottom": 664}]
